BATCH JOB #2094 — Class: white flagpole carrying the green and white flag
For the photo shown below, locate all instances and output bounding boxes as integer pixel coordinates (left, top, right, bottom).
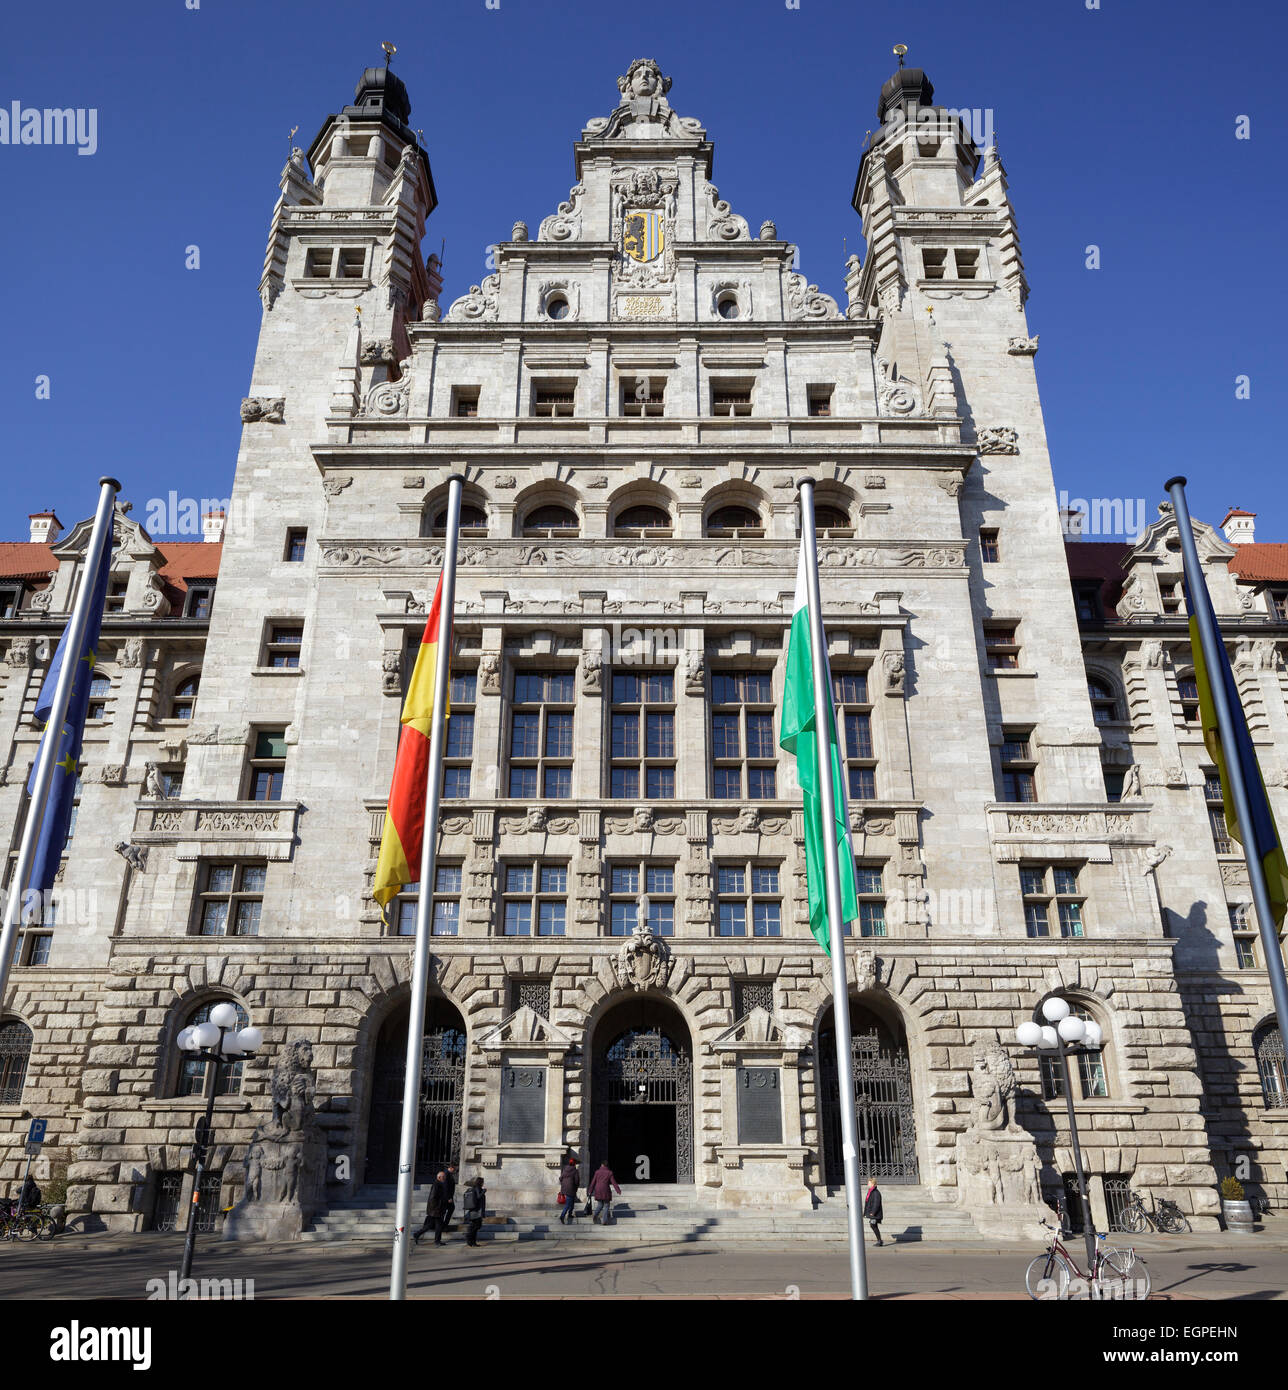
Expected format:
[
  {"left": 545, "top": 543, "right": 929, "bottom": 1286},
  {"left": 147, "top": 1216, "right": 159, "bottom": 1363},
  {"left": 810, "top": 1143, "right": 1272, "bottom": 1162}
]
[{"left": 798, "top": 478, "right": 867, "bottom": 1298}]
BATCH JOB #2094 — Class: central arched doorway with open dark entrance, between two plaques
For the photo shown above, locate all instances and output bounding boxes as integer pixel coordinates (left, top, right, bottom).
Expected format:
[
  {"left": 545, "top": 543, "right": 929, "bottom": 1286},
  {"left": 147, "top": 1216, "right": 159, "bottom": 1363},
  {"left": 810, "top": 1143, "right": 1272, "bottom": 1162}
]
[{"left": 585, "top": 999, "right": 693, "bottom": 1183}]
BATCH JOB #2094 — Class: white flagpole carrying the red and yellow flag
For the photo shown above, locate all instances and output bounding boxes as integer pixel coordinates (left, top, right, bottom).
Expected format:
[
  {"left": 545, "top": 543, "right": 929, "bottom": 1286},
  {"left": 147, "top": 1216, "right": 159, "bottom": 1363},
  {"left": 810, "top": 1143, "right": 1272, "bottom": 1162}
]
[{"left": 389, "top": 473, "right": 465, "bottom": 1302}]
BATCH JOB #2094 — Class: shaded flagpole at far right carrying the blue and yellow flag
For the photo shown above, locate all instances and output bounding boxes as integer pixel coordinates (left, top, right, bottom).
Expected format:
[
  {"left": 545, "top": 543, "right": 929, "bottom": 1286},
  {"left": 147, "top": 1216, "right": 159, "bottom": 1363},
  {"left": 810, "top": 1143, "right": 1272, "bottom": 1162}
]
[{"left": 1163, "top": 477, "right": 1288, "bottom": 1033}]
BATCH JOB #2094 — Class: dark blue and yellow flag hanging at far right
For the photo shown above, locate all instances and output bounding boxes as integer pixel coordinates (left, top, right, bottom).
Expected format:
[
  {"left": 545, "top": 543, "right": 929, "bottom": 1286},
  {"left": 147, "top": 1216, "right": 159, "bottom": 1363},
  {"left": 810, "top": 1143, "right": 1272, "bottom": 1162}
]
[{"left": 1185, "top": 575, "right": 1288, "bottom": 927}]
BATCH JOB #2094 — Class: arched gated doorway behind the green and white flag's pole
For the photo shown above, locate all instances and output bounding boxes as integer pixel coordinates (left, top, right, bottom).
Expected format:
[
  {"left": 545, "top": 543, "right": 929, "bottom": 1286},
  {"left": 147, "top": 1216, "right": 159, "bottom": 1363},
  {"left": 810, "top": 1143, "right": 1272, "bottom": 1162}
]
[{"left": 818, "top": 999, "right": 920, "bottom": 1187}]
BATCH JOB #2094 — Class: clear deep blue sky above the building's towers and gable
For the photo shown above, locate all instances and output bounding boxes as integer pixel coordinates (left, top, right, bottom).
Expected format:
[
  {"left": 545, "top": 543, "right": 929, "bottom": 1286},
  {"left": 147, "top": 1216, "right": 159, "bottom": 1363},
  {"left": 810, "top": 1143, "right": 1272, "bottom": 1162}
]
[{"left": 0, "top": 0, "right": 1288, "bottom": 539}]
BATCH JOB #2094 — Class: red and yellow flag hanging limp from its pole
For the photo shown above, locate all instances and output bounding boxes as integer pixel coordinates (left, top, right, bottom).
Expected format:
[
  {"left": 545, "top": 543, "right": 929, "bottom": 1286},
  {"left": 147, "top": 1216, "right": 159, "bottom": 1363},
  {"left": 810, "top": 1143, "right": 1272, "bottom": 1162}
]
[{"left": 371, "top": 574, "right": 452, "bottom": 910}]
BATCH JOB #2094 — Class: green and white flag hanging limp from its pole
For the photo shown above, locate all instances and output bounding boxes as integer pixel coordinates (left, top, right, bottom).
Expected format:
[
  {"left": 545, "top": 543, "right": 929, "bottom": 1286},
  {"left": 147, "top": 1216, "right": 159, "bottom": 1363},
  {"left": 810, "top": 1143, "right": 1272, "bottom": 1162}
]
[{"left": 778, "top": 537, "right": 859, "bottom": 955}]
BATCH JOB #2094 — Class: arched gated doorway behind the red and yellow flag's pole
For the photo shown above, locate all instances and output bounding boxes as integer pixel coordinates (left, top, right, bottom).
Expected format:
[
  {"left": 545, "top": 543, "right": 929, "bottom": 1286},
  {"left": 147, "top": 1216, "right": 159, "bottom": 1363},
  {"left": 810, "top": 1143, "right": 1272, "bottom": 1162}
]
[{"left": 367, "top": 998, "right": 465, "bottom": 1183}]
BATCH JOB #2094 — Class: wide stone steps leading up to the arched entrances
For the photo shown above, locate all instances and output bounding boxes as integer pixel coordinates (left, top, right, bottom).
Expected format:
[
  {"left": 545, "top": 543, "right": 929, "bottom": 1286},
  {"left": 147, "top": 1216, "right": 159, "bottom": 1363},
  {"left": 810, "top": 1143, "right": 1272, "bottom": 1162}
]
[{"left": 300, "top": 1183, "right": 981, "bottom": 1244}]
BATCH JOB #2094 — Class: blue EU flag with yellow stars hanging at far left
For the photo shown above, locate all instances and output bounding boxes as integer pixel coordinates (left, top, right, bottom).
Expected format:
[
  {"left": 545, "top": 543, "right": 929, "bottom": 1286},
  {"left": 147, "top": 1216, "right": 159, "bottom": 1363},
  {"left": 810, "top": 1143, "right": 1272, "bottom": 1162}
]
[{"left": 26, "top": 516, "right": 115, "bottom": 892}]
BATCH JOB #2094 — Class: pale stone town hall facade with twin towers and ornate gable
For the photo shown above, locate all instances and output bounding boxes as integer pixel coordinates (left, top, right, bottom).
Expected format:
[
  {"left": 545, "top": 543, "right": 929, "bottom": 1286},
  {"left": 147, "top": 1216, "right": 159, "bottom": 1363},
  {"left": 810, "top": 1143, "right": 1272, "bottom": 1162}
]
[{"left": 0, "top": 60, "right": 1288, "bottom": 1229}]
